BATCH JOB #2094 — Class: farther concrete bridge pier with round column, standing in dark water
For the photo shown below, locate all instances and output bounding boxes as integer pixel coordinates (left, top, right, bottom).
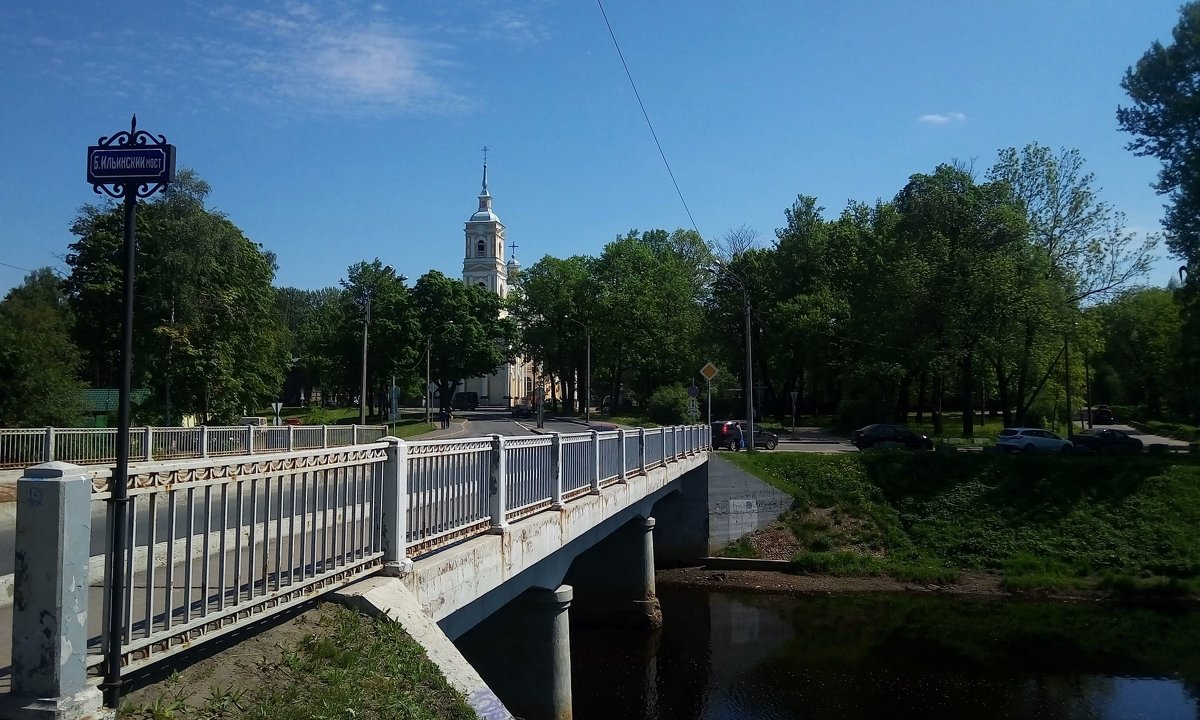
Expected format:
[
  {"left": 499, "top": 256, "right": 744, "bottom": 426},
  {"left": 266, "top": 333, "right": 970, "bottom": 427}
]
[{"left": 566, "top": 516, "right": 662, "bottom": 629}]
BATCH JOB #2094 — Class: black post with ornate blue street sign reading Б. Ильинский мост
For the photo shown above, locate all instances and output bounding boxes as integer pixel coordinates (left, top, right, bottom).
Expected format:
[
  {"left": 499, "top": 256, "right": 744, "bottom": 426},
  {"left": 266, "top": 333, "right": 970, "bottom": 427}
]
[{"left": 88, "top": 115, "right": 175, "bottom": 708}]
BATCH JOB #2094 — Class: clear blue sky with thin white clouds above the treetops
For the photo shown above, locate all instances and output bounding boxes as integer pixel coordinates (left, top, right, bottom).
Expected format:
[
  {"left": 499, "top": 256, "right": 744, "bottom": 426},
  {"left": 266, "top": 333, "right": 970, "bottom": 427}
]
[{"left": 0, "top": 0, "right": 1178, "bottom": 295}]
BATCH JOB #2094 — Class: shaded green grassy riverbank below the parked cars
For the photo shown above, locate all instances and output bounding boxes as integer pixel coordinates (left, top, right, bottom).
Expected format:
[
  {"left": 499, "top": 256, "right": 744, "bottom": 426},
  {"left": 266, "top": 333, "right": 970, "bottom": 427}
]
[{"left": 731, "top": 452, "right": 1200, "bottom": 594}]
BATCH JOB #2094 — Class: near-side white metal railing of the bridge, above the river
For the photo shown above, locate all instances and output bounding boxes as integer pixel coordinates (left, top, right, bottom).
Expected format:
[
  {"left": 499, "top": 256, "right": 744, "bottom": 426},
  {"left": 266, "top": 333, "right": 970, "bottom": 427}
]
[{"left": 0, "top": 426, "right": 710, "bottom": 691}]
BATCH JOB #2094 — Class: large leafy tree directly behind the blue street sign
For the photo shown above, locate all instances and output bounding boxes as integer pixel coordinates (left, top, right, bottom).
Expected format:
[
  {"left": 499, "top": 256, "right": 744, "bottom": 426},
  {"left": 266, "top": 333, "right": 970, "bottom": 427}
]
[{"left": 66, "top": 170, "right": 287, "bottom": 422}]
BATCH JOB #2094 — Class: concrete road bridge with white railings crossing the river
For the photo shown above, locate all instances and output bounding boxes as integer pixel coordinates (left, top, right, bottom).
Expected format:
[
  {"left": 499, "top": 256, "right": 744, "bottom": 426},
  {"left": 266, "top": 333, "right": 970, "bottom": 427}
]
[{"left": 0, "top": 426, "right": 710, "bottom": 718}]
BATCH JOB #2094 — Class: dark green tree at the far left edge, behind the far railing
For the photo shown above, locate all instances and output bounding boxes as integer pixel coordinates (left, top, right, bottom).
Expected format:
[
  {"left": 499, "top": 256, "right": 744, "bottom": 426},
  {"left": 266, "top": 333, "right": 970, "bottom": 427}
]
[{"left": 0, "top": 268, "right": 83, "bottom": 427}]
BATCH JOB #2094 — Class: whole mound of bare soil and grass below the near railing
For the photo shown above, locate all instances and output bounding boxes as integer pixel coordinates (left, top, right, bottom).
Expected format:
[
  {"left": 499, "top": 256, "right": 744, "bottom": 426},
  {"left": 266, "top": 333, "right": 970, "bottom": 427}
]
[{"left": 118, "top": 604, "right": 475, "bottom": 720}]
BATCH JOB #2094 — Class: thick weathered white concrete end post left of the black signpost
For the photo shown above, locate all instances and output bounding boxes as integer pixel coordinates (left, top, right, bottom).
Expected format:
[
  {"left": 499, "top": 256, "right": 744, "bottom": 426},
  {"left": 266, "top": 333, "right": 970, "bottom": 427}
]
[{"left": 0, "top": 462, "right": 112, "bottom": 720}]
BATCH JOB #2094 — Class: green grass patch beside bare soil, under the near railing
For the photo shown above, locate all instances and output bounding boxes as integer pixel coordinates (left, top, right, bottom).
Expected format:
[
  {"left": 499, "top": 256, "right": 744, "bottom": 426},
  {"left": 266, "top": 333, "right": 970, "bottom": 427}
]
[{"left": 118, "top": 605, "right": 475, "bottom": 720}]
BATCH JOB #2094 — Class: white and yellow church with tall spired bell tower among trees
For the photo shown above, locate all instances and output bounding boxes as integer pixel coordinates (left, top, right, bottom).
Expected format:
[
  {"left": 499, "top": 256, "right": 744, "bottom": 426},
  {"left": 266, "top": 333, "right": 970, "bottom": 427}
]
[{"left": 458, "top": 154, "right": 536, "bottom": 406}]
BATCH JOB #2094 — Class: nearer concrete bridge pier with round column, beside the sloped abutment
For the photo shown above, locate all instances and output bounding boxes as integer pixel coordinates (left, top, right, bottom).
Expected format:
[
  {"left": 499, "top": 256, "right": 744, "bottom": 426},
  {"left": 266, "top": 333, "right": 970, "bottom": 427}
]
[{"left": 457, "top": 584, "right": 574, "bottom": 720}]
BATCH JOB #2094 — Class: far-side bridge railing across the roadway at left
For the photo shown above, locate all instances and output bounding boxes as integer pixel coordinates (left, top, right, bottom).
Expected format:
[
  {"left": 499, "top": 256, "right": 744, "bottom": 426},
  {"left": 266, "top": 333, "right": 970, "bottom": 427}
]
[{"left": 0, "top": 425, "right": 388, "bottom": 469}]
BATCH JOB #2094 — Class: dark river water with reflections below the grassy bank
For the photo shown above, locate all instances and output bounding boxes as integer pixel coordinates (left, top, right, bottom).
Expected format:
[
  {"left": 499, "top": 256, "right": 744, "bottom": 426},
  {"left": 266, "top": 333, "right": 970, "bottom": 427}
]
[{"left": 571, "top": 589, "right": 1200, "bottom": 720}]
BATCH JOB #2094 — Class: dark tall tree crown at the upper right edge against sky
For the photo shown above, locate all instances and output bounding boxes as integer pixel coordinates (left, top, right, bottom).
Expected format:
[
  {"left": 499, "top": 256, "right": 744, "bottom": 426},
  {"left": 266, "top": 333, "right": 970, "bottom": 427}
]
[{"left": 1117, "top": 1, "right": 1200, "bottom": 262}]
